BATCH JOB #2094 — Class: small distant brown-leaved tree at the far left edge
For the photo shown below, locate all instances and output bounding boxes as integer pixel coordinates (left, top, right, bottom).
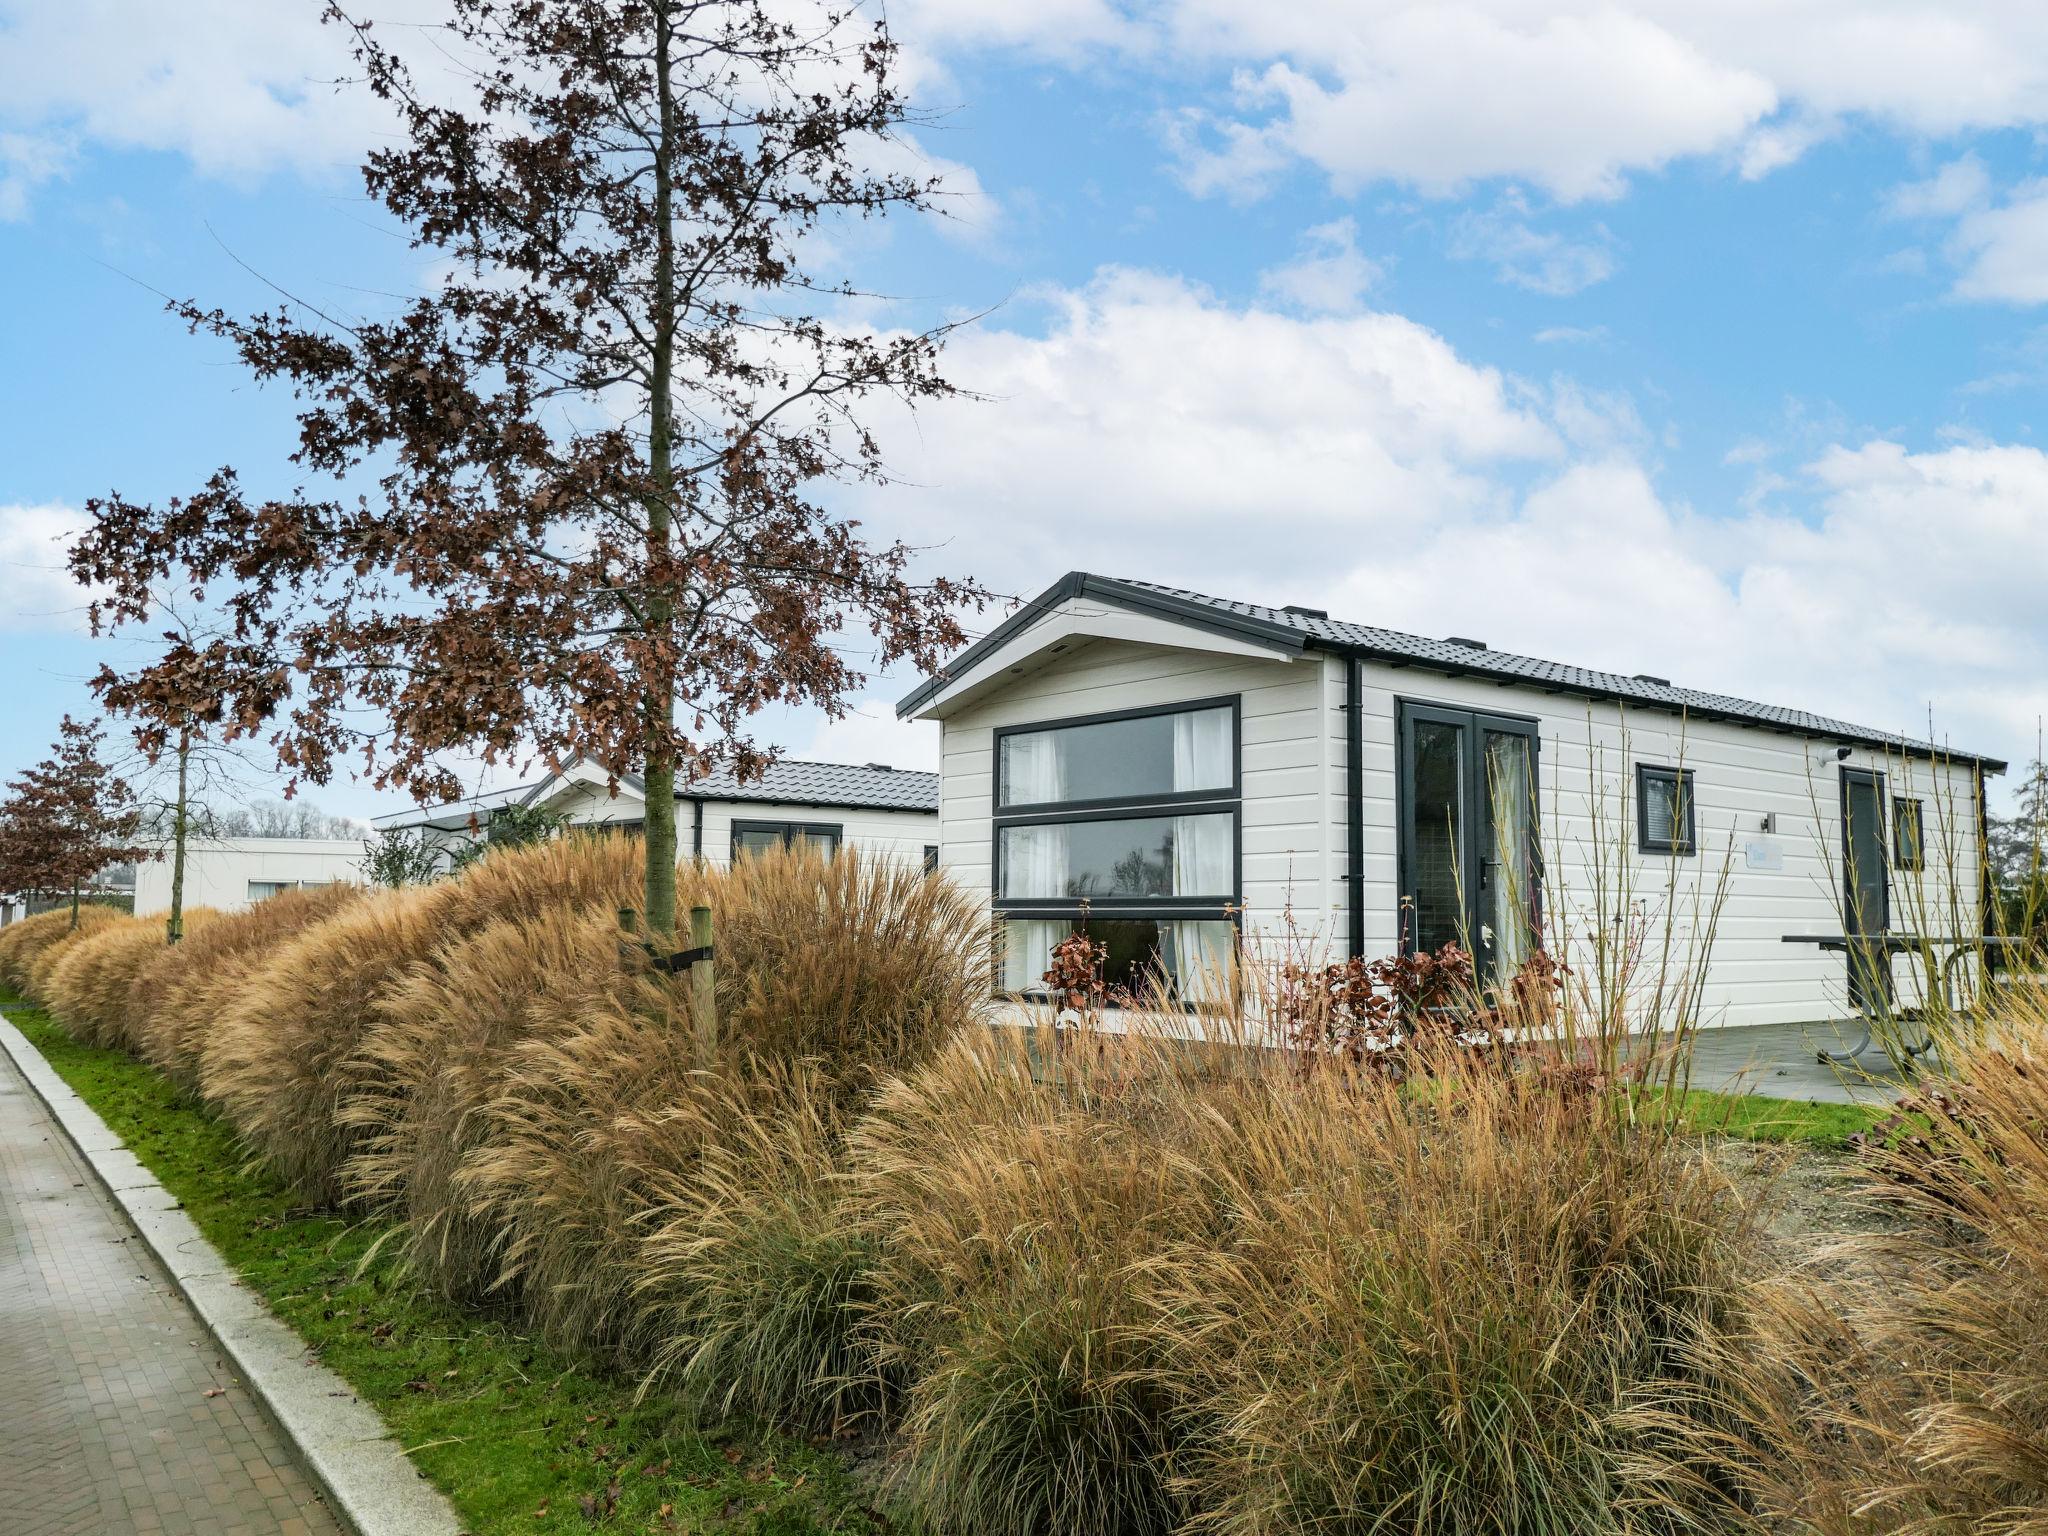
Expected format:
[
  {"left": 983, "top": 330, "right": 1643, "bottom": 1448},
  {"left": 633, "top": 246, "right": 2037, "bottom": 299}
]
[{"left": 0, "top": 715, "right": 150, "bottom": 928}]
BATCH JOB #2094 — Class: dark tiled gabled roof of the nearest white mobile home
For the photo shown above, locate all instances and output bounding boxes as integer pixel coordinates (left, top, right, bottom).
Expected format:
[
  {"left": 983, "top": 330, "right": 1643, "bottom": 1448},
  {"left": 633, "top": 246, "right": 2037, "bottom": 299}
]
[{"left": 897, "top": 571, "right": 2005, "bottom": 772}]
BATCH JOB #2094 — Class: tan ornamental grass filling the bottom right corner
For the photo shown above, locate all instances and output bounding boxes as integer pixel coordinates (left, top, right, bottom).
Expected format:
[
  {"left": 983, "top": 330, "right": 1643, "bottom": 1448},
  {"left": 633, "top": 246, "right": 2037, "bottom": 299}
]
[{"left": 1647, "top": 985, "right": 2048, "bottom": 1536}]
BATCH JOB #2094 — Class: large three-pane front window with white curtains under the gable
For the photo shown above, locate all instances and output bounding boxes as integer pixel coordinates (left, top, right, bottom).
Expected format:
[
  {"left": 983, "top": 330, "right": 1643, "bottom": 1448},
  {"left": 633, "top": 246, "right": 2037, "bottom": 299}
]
[{"left": 993, "top": 698, "right": 1239, "bottom": 991}]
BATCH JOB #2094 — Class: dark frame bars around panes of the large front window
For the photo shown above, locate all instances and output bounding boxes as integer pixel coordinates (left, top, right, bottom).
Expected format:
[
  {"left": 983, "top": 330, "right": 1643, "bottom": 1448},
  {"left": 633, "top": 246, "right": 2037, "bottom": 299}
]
[{"left": 989, "top": 694, "right": 1245, "bottom": 995}]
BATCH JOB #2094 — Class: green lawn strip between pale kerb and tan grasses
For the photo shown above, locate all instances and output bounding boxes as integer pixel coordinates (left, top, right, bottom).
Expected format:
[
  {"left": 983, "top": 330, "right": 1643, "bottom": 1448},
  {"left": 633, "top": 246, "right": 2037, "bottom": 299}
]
[{"left": 0, "top": 997, "right": 893, "bottom": 1536}]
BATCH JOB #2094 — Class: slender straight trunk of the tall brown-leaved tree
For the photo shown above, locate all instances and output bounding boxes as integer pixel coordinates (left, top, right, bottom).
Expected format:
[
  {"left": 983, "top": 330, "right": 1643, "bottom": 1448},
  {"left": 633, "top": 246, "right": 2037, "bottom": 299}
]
[{"left": 641, "top": 4, "right": 676, "bottom": 940}]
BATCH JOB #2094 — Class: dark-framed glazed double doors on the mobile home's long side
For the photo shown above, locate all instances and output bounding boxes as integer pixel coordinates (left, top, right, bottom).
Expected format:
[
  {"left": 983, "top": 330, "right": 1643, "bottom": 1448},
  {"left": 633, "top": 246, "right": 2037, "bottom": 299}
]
[{"left": 1397, "top": 705, "right": 1536, "bottom": 981}]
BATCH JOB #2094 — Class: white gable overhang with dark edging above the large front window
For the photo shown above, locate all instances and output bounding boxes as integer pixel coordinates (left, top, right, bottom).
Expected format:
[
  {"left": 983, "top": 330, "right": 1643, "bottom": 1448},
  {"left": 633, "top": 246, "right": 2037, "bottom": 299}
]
[{"left": 897, "top": 571, "right": 1305, "bottom": 721}]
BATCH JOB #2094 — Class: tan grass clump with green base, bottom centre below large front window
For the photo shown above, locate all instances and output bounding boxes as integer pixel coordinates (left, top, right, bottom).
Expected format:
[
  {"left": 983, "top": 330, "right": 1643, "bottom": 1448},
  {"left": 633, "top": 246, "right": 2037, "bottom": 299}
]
[{"left": 850, "top": 1030, "right": 1221, "bottom": 1536}]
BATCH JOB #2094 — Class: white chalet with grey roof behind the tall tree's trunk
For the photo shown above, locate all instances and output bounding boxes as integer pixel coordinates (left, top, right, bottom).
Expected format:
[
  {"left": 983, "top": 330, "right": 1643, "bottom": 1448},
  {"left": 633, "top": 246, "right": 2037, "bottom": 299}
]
[{"left": 375, "top": 758, "right": 938, "bottom": 868}]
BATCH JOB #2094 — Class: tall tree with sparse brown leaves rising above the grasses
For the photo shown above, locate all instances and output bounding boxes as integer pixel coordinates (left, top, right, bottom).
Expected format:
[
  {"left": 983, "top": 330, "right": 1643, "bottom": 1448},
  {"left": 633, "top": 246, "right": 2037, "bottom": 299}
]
[{"left": 72, "top": 0, "right": 981, "bottom": 934}]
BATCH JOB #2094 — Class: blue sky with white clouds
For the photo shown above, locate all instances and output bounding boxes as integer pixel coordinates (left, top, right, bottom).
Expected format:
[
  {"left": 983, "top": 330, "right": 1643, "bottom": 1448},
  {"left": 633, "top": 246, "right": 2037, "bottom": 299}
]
[{"left": 0, "top": 0, "right": 2048, "bottom": 813}]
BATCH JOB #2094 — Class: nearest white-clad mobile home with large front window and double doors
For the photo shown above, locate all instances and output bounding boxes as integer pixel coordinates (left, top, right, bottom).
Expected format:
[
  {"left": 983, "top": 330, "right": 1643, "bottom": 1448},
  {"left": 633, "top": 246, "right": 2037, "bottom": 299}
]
[{"left": 899, "top": 571, "right": 2005, "bottom": 1024}]
